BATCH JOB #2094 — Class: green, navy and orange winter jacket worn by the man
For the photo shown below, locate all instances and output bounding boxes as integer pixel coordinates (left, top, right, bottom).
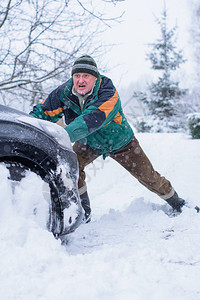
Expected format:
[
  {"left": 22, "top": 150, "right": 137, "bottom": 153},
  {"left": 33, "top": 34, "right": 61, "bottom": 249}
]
[{"left": 30, "top": 74, "right": 134, "bottom": 156}]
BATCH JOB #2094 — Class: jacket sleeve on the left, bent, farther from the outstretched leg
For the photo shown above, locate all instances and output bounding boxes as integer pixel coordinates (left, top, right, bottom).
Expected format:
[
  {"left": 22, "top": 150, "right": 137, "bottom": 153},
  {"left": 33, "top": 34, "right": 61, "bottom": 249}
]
[{"left": 30, "top": 84, "right": 66, "bottom": 123}]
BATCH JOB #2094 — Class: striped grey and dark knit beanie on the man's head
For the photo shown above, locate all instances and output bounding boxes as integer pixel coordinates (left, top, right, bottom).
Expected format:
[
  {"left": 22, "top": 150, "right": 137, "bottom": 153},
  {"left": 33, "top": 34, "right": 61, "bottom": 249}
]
[{"left": 72, "top": 55, "right": 98, "bottom": 77}]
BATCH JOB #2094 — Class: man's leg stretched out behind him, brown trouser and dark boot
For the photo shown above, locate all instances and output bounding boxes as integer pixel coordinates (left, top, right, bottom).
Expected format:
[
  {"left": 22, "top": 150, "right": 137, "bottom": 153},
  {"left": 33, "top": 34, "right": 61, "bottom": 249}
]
[{"left": 111, "top": 137, "right": 185, "bottom": 211}]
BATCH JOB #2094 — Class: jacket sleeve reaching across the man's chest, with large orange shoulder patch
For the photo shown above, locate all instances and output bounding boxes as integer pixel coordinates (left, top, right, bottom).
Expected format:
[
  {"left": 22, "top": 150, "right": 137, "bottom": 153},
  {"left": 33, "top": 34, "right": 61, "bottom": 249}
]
[{"left": 65, "top": 77, "right": 121, "bottom": 142}]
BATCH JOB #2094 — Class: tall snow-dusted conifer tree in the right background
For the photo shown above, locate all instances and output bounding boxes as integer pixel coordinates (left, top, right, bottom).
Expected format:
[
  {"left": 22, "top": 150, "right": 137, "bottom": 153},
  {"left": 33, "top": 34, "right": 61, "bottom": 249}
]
[{"left": 145, "top": 9, "right": 186, "bottom": 119}]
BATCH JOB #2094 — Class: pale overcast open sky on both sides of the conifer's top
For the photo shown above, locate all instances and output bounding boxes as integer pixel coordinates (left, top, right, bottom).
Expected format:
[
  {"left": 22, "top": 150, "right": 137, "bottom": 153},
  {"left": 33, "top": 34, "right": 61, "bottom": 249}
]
[{"left": 99, "top": 0, "right": 192, "bottom": 86}]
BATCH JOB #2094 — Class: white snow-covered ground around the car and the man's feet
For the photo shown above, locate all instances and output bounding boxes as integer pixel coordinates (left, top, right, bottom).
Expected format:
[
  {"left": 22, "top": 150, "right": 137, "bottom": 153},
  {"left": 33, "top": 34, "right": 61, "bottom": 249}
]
[{"left": 0, "top": 134, "right": 200, "bottom": 300}]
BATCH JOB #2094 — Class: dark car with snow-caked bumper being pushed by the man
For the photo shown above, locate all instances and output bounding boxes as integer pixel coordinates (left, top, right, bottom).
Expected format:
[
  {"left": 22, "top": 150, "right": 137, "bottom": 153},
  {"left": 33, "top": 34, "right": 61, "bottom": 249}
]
[{"left": 0, "top": 105, "right": 83, "bottom": 238}]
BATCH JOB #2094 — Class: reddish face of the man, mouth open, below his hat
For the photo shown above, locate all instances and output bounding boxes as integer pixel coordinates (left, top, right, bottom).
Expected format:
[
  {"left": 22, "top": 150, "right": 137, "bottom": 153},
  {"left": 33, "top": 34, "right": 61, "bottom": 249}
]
[{"left": 73, "top": 73, "right": 97, "bottom": 96}]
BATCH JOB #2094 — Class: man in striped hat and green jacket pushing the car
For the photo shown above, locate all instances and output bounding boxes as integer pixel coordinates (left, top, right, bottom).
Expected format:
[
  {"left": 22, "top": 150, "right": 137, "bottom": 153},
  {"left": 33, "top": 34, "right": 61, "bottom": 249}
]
[{"left": 30, "top": 55, "right": 185, "bottom": 222}]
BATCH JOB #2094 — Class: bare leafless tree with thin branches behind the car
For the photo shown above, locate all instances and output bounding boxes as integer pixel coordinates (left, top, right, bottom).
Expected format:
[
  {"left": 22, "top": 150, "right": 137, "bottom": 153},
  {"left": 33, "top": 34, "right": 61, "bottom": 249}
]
[{"left": 0, "top": 0, "right": 120, "bottom": 110}]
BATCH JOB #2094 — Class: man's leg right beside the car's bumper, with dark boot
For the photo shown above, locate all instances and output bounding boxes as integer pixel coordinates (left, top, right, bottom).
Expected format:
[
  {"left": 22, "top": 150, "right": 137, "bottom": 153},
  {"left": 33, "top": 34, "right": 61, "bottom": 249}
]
[{"left": 73, "top": 142, "right": 98, "bottom": 223}]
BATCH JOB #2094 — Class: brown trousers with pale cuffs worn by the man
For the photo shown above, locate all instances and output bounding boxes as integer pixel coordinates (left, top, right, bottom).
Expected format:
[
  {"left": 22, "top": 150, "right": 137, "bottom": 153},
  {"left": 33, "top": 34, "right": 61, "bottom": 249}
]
[{"left": 73, "top": 137, "right": 174, "bottom": 200}]
